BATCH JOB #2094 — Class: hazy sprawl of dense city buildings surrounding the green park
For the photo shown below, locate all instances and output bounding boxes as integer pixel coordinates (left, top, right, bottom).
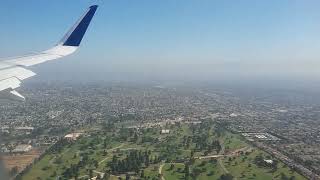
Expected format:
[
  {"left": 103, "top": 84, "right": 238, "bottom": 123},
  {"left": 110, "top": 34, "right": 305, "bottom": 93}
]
[{"left": 0, "top": 84, "right": 320, "bottom": 177}]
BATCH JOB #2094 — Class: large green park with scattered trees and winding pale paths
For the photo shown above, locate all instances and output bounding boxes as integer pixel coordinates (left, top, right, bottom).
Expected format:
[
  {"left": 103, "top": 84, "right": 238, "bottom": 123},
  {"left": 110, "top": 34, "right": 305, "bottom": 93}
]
[{"left": 22, "top": 122, "right": 305, "bottom": 180}]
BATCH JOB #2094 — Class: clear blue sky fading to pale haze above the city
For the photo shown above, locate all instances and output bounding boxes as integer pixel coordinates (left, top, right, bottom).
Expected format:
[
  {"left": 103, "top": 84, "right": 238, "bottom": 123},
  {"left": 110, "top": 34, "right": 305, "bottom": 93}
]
[{"left": 0, "top": 0, "right": 320, "bottom": 80}]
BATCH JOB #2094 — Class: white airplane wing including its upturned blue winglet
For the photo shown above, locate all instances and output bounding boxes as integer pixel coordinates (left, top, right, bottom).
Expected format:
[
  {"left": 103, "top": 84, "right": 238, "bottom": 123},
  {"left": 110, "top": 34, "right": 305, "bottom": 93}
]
[{"left": 0, "top": 5, "right": 98, "bottom": 100}]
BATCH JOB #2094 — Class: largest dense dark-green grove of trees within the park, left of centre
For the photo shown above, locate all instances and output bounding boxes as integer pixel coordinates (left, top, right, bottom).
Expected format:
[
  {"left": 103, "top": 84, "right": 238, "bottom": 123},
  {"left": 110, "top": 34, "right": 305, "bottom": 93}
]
[{"left": 108, "top": 150, "right": 159, "bottom": 174}]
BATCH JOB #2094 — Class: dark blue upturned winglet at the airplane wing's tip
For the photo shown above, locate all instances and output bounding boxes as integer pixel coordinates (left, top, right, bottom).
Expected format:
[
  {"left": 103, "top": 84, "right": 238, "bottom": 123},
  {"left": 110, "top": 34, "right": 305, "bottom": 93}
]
[{"left": 59, "top": 5, "right": 98, "bottom": 46}]
